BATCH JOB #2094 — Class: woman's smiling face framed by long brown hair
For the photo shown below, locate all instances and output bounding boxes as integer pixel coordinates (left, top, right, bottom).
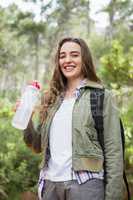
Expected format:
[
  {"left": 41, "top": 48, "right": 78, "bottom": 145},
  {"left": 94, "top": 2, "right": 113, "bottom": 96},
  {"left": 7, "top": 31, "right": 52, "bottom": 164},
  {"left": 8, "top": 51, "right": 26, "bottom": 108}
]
[{"left": 59, "top": 42, "right": 83, "bottom": 80}]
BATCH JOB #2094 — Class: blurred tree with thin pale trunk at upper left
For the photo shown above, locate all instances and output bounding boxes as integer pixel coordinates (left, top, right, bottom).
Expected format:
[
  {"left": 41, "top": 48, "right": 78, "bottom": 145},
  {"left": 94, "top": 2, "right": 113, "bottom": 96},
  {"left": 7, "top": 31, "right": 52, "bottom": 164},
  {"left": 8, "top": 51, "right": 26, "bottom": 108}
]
[{"left": 6, "top": 4, "right": 45, "bottom": 79}]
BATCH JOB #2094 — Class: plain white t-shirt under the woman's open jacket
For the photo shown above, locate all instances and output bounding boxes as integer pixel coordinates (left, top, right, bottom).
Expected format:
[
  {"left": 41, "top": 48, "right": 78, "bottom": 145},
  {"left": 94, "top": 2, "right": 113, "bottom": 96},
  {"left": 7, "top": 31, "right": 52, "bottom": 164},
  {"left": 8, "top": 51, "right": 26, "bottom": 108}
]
[{"left": 45, "top": 98, "right": 75, "bottom": 181}]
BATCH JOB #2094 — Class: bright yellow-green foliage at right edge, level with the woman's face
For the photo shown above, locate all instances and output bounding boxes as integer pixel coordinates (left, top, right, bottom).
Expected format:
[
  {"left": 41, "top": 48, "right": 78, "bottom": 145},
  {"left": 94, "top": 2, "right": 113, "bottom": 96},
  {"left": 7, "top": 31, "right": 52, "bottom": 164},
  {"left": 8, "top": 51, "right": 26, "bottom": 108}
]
[{"left": 100, "top": 40, "right": 133, "bottom": 88}]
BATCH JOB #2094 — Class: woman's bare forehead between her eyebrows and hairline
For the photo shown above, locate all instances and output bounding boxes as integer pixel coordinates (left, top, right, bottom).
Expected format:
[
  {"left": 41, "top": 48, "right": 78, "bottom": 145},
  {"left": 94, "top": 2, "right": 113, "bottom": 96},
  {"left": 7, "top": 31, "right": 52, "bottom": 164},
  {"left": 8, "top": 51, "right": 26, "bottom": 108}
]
[{"left": 60, "top": 42, "right": 81, "bottom": 53}]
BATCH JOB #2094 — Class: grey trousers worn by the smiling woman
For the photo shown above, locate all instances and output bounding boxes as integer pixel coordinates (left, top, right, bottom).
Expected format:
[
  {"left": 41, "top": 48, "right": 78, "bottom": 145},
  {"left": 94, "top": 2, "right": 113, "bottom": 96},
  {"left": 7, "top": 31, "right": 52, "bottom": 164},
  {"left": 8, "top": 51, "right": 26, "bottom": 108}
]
[{"left": 42, "top": 179, "right": 104, "bottom": 200}]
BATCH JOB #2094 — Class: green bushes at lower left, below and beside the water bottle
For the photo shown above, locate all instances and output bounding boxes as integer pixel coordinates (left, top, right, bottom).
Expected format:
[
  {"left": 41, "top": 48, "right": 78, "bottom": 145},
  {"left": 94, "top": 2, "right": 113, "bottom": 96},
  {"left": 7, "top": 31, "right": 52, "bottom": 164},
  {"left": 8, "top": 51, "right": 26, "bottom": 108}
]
[{"left": 0, "top": 101, "right": 41, "bottom": 200}]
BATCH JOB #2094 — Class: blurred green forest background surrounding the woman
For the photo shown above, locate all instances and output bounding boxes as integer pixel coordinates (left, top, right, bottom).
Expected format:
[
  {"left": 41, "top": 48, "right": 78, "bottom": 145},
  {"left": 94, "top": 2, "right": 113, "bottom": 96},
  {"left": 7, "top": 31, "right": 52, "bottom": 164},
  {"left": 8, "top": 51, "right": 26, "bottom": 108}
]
[{"left": 0, "top": 0, "right": 133, "bottom": 200}]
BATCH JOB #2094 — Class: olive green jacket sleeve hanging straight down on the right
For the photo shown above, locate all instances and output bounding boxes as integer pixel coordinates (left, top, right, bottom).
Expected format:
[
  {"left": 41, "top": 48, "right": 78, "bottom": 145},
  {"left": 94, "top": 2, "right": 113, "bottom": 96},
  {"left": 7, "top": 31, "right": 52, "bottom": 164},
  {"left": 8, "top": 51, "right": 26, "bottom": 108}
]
[{"left": 103, "top": 91, "right": 123, "bottom": 200}]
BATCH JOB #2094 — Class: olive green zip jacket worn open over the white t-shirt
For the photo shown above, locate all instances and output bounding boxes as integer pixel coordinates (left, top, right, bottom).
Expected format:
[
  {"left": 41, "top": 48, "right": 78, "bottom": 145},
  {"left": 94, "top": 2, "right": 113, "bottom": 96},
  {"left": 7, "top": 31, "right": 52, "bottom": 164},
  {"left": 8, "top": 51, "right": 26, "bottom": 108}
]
[{"left": 23, "top": 81, "right": 123, "bottom": 200}]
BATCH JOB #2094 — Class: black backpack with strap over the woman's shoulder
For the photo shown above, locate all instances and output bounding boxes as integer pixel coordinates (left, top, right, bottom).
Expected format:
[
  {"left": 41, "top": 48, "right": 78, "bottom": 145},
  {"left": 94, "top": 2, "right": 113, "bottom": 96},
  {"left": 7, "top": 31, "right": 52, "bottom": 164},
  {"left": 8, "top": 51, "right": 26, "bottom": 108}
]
[{"left": 90, "top": 88, "right": 131, "bottom": 200}]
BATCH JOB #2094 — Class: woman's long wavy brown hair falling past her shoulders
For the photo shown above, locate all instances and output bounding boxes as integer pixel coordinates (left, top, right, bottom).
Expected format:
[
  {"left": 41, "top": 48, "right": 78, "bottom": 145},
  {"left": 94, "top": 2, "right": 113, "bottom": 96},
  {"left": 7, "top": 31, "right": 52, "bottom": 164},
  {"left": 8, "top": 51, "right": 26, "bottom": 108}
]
[{"left": 40, "top": 37, "right": 101, "bottom": 122}]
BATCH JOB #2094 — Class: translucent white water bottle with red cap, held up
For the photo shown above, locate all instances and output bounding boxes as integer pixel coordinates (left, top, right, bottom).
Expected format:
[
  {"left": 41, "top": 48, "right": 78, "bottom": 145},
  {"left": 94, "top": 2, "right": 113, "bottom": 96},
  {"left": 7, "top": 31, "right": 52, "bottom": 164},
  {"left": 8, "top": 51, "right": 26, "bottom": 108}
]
[{"left": 12, "top": 81, "right": 40, "bottom": 130}]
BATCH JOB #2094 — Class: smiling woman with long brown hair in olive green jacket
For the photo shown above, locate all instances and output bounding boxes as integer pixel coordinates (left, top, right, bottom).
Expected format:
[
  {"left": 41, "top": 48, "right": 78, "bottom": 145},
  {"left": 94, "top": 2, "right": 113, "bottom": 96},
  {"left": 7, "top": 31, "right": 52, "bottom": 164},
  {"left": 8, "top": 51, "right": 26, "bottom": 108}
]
[{"left": 24, "top": 38, "right": 123, "bottom": 200}]
